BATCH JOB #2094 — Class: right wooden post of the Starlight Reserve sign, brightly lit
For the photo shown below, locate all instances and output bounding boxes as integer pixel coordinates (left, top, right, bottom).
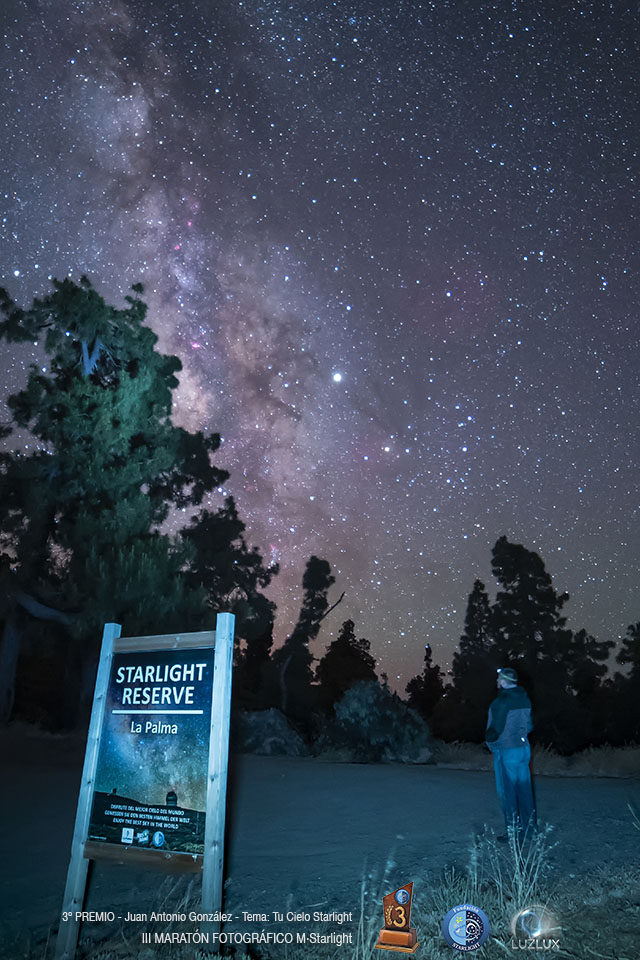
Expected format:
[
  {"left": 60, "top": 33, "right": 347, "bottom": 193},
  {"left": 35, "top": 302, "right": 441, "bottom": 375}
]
[{"left": 202, "top": 613, "right": 235, "bottom": 933}]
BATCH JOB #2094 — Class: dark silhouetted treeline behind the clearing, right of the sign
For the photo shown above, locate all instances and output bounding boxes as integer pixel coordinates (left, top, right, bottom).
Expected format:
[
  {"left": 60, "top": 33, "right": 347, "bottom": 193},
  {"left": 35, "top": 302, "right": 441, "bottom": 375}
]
[{"left": 234, "top": 537, "right": 640, "bottom": 754}]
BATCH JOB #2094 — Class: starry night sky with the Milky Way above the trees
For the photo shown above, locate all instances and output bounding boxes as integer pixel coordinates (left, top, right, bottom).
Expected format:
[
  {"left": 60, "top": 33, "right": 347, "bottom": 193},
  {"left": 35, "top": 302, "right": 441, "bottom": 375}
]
[{"left": 0, "top": 0, "right": 640, "bottom": 691}]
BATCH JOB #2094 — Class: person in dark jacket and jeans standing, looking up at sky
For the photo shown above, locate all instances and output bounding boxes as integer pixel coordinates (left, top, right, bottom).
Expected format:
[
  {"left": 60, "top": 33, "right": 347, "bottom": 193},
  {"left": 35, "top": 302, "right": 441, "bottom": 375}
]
[{"left": 485, "top": 667, "right": 536, "bottom": 841}]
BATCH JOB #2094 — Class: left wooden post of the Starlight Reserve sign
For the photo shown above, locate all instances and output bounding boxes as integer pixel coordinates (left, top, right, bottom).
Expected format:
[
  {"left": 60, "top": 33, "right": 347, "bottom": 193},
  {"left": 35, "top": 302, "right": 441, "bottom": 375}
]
[{"left": 55, "top": 623, "right": 121, "bottom": 960}]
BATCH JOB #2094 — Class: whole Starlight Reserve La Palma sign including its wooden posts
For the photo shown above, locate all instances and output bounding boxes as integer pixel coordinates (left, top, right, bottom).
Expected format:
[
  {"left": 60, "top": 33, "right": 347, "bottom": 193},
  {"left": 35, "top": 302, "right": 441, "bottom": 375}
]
[{"left": 56, "top": 613, "right": 234, "bottom": 960}]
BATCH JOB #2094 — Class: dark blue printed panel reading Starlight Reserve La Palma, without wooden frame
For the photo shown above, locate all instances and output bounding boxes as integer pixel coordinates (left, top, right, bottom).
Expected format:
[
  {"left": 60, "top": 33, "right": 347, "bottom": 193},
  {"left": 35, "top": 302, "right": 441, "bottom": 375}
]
[{"left": 87, "top": 648, "right": 213, "bottom": 854}]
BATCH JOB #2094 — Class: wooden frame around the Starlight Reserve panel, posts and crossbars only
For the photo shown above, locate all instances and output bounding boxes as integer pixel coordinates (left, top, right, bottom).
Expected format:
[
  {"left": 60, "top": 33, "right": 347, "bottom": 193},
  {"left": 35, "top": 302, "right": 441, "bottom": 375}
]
[{"left": 55, "top": 613, "right": 235, "bottom": 960}]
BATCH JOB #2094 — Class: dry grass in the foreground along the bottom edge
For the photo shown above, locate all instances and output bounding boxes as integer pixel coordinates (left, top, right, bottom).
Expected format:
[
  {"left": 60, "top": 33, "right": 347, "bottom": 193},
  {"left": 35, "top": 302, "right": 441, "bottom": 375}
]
[{"left": 13, "top": 804, "right": 640, "bottom": 960}]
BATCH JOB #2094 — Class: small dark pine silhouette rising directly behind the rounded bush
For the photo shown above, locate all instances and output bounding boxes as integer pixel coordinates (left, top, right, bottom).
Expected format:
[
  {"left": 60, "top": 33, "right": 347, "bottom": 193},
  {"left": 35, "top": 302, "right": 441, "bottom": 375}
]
[{"left": 316, "top": 620, "right": 378, "bottom": 710}]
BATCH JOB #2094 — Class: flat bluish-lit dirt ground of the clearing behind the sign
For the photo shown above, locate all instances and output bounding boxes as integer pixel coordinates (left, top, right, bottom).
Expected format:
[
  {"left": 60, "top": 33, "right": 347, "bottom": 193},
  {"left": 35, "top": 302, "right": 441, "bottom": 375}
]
[{"left": 0, "top": 728, "right": 640, "bottom": 958}]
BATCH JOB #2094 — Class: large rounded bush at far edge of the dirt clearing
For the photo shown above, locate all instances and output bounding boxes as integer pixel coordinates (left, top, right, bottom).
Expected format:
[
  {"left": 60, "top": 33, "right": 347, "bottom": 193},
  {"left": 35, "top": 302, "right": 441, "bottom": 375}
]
[{"left": 322, "top": 681, "right": 431, "bottom": 763}]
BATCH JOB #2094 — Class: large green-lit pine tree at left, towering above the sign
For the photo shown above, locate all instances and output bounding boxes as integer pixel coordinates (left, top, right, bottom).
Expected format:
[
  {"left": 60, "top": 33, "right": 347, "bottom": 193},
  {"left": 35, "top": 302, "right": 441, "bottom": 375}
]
[{"left": 0, "top": 278, "right": 268, "bottom": 718}]
